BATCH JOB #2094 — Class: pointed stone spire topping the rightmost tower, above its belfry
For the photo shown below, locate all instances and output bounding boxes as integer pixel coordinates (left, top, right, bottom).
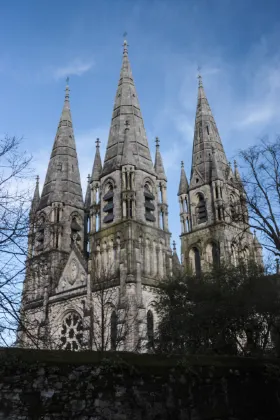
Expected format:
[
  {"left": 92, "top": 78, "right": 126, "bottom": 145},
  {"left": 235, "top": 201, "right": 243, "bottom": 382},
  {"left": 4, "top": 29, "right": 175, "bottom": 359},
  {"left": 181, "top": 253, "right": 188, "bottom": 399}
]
[{"left": 190, "top": 75, "right": 227, "bottom": 188}]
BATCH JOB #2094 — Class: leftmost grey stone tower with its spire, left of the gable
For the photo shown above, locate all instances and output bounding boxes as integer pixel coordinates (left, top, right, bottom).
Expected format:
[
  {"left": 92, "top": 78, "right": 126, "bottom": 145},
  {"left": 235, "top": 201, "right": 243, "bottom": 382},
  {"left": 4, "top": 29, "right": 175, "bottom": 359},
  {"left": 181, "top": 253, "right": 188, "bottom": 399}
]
[{"left": 19, "top": 81, "right": 85, "bottom": 345}]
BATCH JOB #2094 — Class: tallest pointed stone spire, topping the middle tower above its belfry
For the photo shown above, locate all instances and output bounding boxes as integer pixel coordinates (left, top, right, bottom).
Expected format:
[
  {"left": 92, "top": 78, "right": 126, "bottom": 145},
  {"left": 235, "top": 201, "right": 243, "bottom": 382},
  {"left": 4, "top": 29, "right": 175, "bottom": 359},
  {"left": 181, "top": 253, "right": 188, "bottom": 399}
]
[{"left": 102, "top": 37, "right": 154, "bottom": 176}]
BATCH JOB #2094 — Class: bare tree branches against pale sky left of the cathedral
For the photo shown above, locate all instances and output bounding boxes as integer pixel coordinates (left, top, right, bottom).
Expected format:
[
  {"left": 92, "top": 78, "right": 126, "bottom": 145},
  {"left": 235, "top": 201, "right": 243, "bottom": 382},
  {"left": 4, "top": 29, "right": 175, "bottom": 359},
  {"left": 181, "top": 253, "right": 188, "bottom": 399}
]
[{"left": 0, "top": 137, "right": 31, "bottom": 345}]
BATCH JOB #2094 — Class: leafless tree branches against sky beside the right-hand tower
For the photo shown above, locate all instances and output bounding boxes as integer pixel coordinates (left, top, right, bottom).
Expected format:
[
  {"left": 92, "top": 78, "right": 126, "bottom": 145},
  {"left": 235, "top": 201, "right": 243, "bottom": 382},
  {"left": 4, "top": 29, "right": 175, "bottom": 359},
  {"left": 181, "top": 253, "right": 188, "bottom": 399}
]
[{"left": 237, "top": 137, "right": 280, "bottom": 257}]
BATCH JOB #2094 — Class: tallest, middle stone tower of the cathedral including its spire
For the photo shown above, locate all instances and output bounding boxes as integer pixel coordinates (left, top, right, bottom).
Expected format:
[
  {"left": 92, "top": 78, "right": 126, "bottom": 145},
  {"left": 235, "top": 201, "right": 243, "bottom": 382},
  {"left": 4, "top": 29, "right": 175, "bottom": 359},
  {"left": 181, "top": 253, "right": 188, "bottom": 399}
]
[{"left": 89, "top": 41, "right": 172, "bottom": 350}]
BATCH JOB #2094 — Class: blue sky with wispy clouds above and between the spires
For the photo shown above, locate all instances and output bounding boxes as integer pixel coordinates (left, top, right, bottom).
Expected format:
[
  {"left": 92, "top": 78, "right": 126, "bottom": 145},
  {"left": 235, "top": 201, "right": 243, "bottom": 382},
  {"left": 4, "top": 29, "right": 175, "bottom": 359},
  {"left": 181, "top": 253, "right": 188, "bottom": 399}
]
[{"left": 0, "top": 0, "right": 280, "bottom": 245}]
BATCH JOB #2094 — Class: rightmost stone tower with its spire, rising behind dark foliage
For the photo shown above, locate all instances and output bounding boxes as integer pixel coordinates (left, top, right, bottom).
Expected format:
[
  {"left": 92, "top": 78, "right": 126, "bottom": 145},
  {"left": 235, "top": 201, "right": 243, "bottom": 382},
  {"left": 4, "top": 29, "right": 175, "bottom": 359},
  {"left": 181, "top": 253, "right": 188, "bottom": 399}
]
[{"left": 178, "top": 76, "right": 262, "bottom": 273}]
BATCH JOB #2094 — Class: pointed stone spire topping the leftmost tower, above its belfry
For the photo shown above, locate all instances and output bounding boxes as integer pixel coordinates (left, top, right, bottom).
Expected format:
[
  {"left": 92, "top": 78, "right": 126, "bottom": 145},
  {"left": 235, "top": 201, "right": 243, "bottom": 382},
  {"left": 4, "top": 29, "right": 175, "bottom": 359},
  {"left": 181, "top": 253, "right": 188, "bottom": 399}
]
[{"left": 39, "top": 79, "right": 83, "bottom": 209}]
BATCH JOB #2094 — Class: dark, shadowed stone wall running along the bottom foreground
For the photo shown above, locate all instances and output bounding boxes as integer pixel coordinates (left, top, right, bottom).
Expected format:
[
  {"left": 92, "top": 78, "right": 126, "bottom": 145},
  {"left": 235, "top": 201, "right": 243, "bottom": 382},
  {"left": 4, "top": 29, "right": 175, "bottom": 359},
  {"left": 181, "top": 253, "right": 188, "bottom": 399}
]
[{"left": 0, "top": 349, "right": 280, "bottom": 420}]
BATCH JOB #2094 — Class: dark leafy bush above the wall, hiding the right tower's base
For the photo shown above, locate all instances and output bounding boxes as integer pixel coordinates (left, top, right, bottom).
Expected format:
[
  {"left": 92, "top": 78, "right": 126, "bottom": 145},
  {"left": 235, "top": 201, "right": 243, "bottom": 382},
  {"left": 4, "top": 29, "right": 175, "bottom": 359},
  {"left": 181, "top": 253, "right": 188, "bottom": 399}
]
[{"left": 155, "top": 263, "right": 280, "bottom": 355}]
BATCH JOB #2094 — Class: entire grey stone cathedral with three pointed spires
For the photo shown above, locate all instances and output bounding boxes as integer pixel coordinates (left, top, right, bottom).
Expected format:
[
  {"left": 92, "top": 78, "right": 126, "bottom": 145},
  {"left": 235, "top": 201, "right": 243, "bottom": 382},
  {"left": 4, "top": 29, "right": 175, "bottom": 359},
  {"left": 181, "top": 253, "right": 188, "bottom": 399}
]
[{"left": 17, "top": 41, "right": 262, "bottom": 351}]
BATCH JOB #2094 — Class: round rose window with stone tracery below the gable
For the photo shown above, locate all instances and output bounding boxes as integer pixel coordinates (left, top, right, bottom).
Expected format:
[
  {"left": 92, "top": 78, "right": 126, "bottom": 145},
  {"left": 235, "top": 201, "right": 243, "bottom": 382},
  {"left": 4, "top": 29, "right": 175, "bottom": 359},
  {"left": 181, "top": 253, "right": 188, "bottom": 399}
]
[{"left": 60, "top": 313, "right": 83, "bottom": 350}]
